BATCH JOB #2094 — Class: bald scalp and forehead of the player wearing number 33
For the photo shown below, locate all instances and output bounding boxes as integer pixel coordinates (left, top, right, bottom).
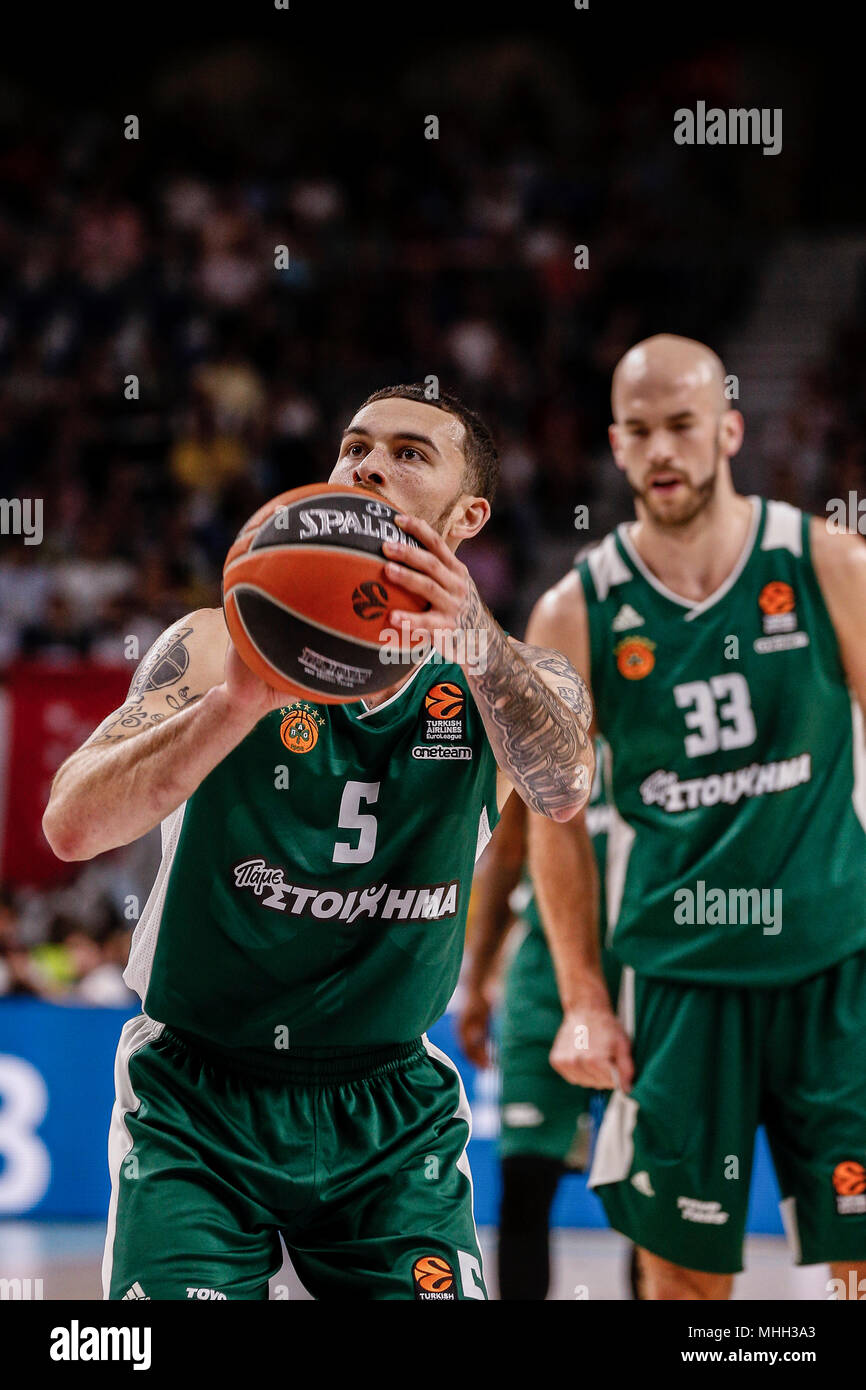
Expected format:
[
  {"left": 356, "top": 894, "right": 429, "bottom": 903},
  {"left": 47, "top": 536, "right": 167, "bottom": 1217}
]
[{"left": 610, "top": 334, "right": 730, "bottom": 420}]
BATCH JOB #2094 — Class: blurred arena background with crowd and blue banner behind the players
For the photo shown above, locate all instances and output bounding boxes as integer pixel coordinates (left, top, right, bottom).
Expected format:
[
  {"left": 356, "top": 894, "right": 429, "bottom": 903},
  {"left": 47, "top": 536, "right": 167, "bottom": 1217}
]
[{"left": 0, "top": 0, "right": 866, "bottom": 1298}]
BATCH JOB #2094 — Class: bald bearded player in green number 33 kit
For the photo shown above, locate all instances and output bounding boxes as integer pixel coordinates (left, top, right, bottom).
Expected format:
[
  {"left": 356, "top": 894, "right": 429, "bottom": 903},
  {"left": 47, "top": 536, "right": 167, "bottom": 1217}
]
[{"left": 527, "top": 335, "right": 866, "bottom": 1300}]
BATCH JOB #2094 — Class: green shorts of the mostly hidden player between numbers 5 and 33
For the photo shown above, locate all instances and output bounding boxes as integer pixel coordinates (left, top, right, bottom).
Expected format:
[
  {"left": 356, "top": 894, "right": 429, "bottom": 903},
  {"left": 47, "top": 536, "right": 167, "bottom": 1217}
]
[{"left": 499, "top": 930, "right": 619, "bottom": 1172}]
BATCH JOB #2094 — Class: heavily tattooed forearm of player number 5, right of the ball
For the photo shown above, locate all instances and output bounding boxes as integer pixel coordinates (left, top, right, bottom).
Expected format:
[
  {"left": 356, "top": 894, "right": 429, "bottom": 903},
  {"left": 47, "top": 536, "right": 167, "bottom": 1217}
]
[{"left": 461, "top": 591, "right": 594, "bottom": 816}]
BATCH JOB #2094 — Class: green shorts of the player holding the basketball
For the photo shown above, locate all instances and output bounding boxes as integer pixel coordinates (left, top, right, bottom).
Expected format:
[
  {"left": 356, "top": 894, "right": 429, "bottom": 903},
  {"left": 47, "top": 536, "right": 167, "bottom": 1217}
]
[{"left": 103, "top": 1015, "right": 487, "bottom": 1302}]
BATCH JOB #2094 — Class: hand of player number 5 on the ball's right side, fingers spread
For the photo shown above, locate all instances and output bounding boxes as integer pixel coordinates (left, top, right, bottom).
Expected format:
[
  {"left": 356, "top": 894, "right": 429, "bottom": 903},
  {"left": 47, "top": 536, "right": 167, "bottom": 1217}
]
[{"left": 382, "top": 516, "right": 491, "bottom": 658}]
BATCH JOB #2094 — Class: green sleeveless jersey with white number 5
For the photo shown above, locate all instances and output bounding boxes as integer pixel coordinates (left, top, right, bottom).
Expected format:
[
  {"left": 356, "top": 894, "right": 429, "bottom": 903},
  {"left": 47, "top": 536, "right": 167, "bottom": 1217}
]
[{"left": 125, "top": 656, "right": 499, "bottom": 1055}]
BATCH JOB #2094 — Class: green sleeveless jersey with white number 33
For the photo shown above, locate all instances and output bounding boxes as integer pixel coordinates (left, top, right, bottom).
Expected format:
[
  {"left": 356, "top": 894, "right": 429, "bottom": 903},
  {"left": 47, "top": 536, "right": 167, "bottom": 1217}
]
[{"left": 578, "top": 498, "right": 866, "bottom": 986}]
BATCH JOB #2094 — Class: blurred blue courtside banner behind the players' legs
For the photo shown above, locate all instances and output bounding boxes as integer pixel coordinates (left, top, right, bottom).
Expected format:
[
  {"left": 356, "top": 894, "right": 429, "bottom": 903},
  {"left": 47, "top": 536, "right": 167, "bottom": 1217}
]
[{"left": 0, "top": 999, "right": 781, "bottom": 1234}]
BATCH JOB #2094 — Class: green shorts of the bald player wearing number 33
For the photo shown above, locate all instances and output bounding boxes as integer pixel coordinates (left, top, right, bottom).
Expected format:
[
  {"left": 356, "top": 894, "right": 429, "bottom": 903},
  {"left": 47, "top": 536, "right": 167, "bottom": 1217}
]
[{"left": 589, "top": 952, "right": 866, "bottom": 1275}]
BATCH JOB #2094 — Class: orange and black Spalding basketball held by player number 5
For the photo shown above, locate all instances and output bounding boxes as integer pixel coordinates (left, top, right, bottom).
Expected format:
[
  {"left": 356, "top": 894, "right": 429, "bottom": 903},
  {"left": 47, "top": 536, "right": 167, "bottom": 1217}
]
[{"left": 222, "top": 482, "right": 428, "bottom": 705}]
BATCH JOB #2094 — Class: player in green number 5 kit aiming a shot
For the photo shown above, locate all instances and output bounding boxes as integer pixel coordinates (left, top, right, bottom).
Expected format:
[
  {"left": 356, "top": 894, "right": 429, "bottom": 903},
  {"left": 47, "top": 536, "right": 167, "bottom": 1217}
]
[{"left": 43, "top": 386, "right": 594, "bottom": 1301}]
